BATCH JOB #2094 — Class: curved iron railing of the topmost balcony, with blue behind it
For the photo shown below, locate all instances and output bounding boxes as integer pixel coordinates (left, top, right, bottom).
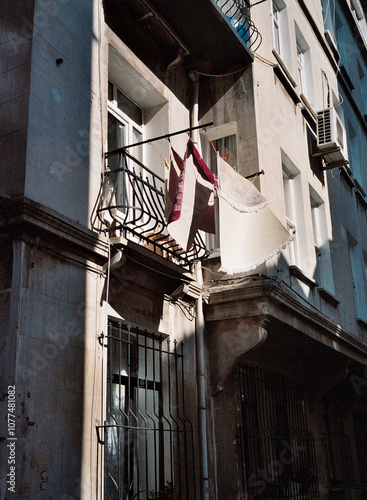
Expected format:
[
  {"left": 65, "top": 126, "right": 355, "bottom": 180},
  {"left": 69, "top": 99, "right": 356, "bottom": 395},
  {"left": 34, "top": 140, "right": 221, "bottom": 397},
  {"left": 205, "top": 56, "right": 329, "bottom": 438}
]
[{"left": 217, "top": 0, "right": 262, "bottom": 52}]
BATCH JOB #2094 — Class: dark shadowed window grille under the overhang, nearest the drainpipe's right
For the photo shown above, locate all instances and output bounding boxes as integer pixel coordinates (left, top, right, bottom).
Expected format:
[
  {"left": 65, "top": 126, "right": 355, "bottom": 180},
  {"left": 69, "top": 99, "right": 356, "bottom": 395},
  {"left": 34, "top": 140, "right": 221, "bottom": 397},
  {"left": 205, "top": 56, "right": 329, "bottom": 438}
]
[{"left": 238, "top": 363, "right": 319, "bottom": 500}]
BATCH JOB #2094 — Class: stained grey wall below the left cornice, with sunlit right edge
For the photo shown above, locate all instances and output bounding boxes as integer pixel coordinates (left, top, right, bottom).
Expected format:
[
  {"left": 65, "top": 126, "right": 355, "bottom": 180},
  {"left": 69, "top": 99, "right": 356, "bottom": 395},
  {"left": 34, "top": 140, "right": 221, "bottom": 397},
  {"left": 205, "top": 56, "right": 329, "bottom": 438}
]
[{"left": 1, "top": 237, "right": 103, "bottom": 498}]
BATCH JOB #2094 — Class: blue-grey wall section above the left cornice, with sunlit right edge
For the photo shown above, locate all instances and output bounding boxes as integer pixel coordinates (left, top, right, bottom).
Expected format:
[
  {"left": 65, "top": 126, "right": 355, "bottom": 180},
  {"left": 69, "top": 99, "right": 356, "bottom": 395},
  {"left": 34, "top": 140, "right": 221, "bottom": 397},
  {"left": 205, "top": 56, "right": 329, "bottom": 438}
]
[{"left": 25, "top": 0, "right": 103, "bottom": 226}]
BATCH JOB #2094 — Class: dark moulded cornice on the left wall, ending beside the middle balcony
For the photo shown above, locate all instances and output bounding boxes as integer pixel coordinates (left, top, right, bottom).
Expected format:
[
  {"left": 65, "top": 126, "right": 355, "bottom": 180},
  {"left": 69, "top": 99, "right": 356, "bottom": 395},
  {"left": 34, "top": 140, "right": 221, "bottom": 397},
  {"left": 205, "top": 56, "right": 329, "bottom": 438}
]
[{"left": 0, "top": 196, "right": 108, "bottom": 263}]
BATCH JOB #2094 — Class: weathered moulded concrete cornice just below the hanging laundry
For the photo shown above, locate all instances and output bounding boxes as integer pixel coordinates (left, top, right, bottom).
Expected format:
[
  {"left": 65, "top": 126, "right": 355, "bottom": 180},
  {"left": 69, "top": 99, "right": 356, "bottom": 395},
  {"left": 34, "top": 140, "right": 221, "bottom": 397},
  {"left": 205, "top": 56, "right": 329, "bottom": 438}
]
[{"left": 205, "top": 276, "right": 367, "bottom": 363}]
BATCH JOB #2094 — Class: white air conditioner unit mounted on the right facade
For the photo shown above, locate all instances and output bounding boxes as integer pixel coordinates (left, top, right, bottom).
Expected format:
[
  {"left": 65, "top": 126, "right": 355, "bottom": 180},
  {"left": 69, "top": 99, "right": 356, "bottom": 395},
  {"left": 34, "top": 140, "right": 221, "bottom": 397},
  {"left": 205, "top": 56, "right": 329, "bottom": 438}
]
[{"left": 317, "top": 108, "right": 347, "bottom": 163}]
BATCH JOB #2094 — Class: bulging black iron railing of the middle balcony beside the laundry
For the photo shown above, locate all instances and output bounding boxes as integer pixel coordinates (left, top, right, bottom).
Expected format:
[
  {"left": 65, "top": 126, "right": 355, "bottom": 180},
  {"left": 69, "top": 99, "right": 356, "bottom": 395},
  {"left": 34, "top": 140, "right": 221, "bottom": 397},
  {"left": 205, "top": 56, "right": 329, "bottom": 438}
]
[{"left": 97, "top": 151, "right": 209, "bottom": 266}]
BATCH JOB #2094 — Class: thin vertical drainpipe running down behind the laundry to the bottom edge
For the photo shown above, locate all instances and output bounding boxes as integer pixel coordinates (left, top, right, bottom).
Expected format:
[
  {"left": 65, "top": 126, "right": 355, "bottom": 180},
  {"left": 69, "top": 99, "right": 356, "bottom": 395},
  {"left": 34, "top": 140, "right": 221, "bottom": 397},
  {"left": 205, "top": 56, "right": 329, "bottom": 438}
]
[{"left": 189, "top": 72, "right": 209, "bottom": 500}]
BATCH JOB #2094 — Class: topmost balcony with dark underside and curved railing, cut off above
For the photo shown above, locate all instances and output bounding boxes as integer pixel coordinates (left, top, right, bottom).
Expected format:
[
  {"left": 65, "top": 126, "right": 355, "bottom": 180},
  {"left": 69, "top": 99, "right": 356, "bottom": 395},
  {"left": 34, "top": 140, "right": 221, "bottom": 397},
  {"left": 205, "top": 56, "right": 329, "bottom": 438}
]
[{"left": 104, "top": 0, "right": 261, "bottom": 78}]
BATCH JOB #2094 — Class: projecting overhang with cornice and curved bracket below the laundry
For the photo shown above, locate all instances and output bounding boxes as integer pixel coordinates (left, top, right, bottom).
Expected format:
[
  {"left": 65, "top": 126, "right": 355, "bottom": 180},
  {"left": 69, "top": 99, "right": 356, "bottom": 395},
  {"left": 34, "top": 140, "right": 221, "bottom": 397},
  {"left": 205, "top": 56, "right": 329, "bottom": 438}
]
[{"left": 205, "top": 275, "right": 367, "bottom": 392}]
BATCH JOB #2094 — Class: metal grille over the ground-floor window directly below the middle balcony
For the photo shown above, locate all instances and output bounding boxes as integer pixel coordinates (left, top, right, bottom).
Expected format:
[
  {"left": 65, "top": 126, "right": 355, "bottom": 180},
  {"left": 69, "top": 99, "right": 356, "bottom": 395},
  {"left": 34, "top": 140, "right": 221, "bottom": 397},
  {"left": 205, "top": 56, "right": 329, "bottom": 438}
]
[{"left": 104, "top": 323, "right": 197, "bottom": 500}]
